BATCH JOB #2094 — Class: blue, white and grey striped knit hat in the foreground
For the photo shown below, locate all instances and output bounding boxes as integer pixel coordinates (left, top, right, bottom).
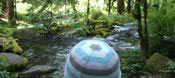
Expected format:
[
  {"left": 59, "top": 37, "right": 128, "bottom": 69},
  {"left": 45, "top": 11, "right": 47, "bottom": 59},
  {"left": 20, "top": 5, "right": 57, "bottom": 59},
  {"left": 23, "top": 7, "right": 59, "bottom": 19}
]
[{"left": 64, "top": 39, "right": 121, "bottom": 78}]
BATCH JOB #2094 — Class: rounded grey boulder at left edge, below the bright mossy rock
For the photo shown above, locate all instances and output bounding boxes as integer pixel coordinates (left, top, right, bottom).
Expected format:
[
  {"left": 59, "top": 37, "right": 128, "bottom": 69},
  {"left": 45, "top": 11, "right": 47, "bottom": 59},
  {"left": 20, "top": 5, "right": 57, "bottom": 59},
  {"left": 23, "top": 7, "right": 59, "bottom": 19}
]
[{"left": 0, "top": 53, "right": 28, "bottom": 71}]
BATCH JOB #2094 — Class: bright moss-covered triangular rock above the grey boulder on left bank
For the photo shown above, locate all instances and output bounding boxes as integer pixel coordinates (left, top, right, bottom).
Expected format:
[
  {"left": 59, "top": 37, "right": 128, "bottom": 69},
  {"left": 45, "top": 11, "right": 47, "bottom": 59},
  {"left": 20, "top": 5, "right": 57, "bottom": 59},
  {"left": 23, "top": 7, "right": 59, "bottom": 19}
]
[{"left": 3, "top": 37, "right": 23, "bottom": 54}]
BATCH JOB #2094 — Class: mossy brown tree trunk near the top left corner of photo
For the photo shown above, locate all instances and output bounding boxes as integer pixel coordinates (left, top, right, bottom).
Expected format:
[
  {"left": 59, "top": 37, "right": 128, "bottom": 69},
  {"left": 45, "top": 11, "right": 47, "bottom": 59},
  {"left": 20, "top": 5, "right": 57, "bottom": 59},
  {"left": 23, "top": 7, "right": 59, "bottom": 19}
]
[{"left": 6, "top": 0, "right": 16, "bottom": 25}]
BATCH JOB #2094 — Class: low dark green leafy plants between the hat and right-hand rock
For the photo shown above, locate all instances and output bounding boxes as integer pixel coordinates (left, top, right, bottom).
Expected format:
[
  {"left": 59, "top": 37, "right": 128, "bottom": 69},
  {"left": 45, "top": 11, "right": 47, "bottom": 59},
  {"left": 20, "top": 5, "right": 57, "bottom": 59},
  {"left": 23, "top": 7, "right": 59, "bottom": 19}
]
[{"left": 121, "top": 51, "right": 148, "bottom": 76}]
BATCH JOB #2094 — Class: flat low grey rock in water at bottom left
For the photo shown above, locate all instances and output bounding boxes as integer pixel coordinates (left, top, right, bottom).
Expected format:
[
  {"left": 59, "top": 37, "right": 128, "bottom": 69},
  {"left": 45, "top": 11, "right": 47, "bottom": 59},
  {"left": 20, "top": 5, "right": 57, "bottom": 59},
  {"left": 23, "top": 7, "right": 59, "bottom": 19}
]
[{"left": 20, "top": 65, "right": 58, "bottom": 78}]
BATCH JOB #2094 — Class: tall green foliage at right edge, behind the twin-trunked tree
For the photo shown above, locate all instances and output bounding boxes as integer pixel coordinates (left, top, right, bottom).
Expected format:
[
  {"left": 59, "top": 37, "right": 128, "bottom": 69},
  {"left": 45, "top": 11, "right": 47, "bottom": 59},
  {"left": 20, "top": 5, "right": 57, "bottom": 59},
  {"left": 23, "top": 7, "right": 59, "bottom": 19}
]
[{"left": 149, "top": 2, "right": 175, "bottom": 58}]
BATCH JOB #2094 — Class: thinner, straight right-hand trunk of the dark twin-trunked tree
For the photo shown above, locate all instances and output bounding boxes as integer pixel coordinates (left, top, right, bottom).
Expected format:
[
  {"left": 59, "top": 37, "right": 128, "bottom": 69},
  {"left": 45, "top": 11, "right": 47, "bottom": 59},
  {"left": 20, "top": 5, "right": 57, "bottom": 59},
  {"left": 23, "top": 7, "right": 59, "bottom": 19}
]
[{"left": 143, "top": 0, "right": 150, "bottom": 57}]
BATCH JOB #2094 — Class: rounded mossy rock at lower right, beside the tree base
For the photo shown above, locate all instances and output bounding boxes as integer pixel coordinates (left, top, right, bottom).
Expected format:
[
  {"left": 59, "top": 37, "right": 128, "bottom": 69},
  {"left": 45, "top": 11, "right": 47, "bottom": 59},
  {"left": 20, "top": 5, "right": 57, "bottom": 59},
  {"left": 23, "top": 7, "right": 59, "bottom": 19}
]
[{"left": 145, "top": 53, "right": 171, "bottom": 73}]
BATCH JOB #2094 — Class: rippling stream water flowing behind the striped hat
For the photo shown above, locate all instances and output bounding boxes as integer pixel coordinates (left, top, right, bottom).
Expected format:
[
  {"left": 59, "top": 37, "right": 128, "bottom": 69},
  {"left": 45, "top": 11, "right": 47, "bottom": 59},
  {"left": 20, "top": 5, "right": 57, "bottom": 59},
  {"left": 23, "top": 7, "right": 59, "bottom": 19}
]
[{"left": 14, "top": 23, "right": 139, "bottom": 78}]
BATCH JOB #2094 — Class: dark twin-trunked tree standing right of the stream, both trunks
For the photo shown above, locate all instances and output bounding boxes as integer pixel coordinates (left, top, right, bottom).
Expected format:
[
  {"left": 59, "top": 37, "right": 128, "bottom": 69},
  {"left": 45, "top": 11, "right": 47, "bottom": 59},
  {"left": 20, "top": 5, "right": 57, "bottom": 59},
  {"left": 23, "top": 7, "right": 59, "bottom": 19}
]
[{"left": 135, "top": 0, "right": 149, "bottom": 57}]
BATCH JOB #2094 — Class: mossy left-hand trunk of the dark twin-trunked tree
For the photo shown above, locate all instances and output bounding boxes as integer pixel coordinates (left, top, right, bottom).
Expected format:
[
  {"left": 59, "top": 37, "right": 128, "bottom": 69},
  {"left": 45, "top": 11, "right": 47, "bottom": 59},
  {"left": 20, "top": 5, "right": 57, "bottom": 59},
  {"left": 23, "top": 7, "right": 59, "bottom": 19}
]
[{"left": 135, "top": 0, "right": 147, "bottom": 56}]
